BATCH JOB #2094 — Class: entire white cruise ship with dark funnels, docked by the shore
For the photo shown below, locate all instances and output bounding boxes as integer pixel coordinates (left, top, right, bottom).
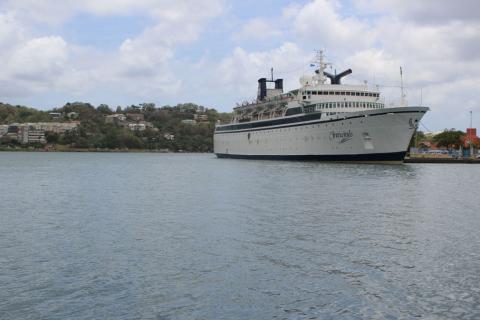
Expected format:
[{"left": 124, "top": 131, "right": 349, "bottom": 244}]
[{"left": 214, "top": 51, "right": 429, "bottom": 163}]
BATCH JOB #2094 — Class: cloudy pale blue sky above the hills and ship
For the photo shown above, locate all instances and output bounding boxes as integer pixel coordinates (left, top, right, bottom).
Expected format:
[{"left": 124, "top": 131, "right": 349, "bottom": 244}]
[{"left": 0, "top": 0, "right": 480, "bottom": 131}]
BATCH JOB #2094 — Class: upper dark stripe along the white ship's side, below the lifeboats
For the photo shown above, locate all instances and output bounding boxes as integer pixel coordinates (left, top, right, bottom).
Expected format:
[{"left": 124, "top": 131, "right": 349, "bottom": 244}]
[{"left": 215, "top": 111, "right": 426, "bottom": 134}]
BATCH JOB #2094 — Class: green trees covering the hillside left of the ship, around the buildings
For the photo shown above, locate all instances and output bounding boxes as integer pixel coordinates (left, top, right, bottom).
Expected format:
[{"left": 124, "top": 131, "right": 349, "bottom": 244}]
[{"left": 0, "top": 102, "right": 231, "bottom": 152}]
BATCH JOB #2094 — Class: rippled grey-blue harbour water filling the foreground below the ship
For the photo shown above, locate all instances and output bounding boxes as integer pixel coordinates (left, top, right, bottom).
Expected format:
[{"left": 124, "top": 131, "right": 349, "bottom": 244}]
[{"left": 0, "top": 153, "right": 480, "bottom": 320}]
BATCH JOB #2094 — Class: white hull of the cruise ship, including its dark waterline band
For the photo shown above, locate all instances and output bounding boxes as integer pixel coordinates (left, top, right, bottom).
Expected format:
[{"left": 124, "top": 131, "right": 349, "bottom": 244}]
[{"left": 214, "top": 107, "right": 428, "bottom": 162}]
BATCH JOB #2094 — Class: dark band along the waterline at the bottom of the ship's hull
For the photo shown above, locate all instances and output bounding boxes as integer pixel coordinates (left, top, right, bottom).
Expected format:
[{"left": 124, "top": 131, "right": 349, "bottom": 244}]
[{"left": 216, "top": 151, "right": 406, "bottom": 162}]
